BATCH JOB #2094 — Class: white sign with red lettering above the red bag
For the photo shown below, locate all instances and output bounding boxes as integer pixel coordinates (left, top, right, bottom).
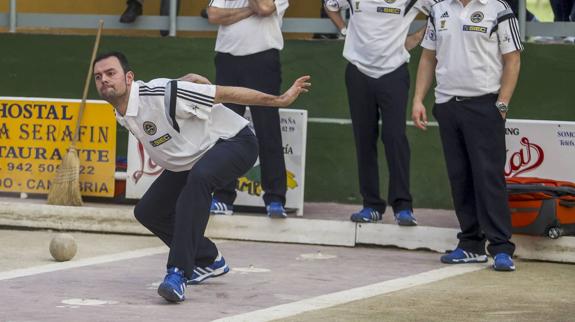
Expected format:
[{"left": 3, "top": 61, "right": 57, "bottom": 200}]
[{"left": 505, "top": 120, "right": 575, "bottom": 182}]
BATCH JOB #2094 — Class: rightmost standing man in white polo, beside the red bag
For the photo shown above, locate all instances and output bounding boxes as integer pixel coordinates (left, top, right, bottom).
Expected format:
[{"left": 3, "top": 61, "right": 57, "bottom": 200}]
[{"left": 412, "top": 0, "right": 523, "bottom": 271}]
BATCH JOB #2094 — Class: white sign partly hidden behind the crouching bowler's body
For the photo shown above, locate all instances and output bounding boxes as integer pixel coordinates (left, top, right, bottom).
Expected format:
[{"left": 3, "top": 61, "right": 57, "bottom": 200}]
[{"left": 126, "top": 109, "right": 307, "bottom": 216}]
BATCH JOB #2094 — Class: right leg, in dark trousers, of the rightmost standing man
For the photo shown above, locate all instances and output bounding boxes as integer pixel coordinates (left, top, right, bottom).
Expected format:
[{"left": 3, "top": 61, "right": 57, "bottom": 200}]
[{"left": 461, "top": 95, "right": 515, "bottom": 256}]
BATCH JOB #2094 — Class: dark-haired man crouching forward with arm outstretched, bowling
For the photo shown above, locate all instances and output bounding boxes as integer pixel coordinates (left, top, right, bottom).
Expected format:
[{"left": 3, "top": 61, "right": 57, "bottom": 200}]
[{"left": 94, "top": 52, "right": 310, "bottom": 302}]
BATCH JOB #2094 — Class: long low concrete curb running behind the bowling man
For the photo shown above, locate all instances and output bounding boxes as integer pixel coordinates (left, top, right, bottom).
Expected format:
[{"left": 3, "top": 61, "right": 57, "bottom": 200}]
[{"left": 0, "top": 202, "right": 575, "bottom": 263}]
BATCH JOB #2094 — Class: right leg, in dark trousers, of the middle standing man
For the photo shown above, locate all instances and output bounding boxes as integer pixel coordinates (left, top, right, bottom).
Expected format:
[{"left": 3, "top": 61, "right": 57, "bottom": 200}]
[{"left": 374, "top": 64, "right": 413, "bottom": 214}]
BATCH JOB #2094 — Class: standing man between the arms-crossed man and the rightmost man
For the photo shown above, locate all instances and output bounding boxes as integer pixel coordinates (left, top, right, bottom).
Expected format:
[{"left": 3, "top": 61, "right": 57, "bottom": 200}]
[{"left": 325, "top": 0, "right": 432, "bottom": 226}]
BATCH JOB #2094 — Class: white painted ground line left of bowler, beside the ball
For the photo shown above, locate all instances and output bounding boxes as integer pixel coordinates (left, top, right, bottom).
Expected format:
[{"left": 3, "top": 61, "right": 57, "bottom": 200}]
[{"left": 0, "top": 246, "right": 168, "bottom": 281}]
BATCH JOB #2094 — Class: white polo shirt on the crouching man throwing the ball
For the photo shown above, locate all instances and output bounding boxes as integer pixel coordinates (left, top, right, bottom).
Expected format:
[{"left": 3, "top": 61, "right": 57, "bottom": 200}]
[{"left": 116, "top": 78, "right": 248, "bottom": 171}]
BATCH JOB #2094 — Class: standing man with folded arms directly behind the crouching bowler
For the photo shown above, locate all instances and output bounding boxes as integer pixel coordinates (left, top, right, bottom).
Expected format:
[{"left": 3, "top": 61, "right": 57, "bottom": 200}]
[{"left": 208, "top": 0, "right": 289, "bottom": 218}]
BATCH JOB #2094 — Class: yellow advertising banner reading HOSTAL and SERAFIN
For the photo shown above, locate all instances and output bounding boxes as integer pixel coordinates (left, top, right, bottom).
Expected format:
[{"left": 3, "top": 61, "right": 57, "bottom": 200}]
[{"left": 0, "top": 97, "right": 116, "bottom": 197}]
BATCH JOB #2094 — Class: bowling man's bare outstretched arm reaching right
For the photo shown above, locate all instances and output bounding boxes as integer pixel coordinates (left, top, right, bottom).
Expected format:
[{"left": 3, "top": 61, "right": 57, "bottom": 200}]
[{"left": 214, "top": 76, "right": 311, "bottom": 107}]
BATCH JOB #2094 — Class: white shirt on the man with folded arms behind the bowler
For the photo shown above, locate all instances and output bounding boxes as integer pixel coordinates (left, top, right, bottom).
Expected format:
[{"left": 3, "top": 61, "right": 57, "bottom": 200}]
[{"left": 209, "top": 0, "right": 289, "bottom": 56}]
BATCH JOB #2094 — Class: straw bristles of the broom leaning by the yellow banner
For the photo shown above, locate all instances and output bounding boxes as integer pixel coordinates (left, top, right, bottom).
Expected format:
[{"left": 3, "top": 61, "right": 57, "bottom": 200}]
[{"left": 48, "top": 147, "right": 82, "bottom": 206}]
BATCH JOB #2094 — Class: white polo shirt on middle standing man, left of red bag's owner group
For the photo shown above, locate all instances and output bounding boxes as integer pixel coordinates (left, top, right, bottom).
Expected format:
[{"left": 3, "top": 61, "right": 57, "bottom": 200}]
[{"left": 325, "top": 0, "right": 434, "bottom": 78}]
